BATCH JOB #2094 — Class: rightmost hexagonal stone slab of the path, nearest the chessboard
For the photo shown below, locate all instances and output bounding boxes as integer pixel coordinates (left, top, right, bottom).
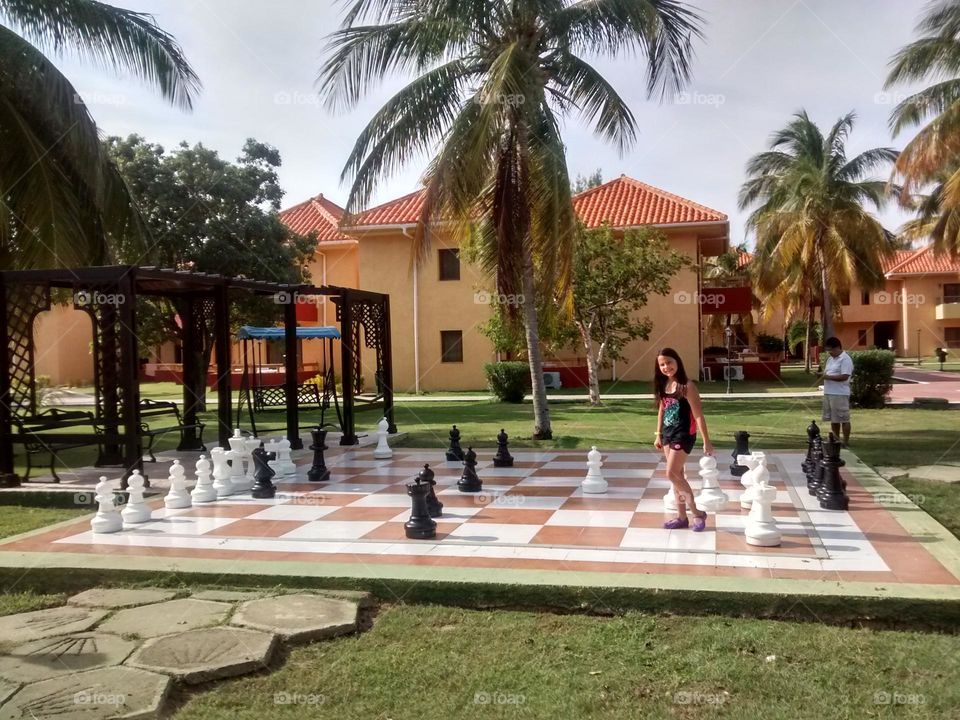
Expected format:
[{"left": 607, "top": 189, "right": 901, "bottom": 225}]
[{"left": 231, "top": 594, "right": 357, "bottom": 643}]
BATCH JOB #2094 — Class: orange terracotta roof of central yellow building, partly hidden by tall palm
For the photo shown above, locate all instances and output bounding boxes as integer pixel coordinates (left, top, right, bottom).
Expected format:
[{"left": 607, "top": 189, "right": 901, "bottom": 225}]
[{"left": 349, "top": 175, "right": 727, "bottom": 228}]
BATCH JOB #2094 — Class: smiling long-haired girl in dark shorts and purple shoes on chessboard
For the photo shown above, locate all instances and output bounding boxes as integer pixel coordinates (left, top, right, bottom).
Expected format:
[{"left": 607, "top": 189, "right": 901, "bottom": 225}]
[{"left": 653, "top": 348, "right": 713, "bottom": 532}]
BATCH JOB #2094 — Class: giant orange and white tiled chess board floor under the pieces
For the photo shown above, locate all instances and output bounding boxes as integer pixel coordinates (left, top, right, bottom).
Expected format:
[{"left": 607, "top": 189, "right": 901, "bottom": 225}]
[{"left": 0, "top": 448, "right": 960, "bottom": 585}]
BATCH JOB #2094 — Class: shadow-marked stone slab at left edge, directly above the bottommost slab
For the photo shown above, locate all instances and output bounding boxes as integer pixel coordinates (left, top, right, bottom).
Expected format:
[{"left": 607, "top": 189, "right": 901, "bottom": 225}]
[{"left": 0, "top": 633, "right": 137, "bottom": 683}]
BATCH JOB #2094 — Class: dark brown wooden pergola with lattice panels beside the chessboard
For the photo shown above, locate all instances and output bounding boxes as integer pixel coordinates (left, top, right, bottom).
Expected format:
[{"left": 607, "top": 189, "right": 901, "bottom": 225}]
[{"left": 0, "top": 265, "right": 396, "bottom": 486}]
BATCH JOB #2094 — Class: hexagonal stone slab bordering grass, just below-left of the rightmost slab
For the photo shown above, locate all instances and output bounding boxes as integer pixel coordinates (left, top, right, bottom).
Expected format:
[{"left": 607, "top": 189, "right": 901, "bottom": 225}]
[{"left": 127, "top": 627, "right": 277, "bottom": 684}]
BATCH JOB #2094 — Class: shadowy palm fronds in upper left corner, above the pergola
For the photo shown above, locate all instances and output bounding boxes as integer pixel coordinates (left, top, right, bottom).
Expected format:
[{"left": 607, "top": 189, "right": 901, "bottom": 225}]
[{"left": 0, "top": 0, "right": 199, "bottom": 269}]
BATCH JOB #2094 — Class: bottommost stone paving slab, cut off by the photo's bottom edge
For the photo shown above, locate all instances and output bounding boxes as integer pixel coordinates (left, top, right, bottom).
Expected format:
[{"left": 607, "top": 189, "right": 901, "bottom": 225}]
[{"left": 0, "top": 667, "right": 172, "bottom": 720}]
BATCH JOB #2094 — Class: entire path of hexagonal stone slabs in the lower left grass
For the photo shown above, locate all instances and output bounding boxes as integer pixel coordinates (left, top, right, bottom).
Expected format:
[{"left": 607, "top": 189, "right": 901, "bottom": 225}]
[{"left": 0, "top": 588, "right": 373, "bottom": 720}]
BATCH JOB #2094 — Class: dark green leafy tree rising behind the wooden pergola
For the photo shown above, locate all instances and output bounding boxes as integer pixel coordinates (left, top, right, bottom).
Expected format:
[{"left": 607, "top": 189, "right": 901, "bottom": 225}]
[{"left": 107, "top": 135, "right": 316, "bottom": 409}]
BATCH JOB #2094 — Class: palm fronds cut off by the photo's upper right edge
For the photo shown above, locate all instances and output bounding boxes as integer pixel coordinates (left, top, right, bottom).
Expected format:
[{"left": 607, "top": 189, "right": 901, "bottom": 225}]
[{"left": 886, "top": 0, "right": 960, "bottom": 257}]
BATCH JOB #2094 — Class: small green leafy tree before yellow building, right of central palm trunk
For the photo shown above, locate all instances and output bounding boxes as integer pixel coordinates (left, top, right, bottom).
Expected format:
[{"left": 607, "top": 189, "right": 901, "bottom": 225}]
[{"left": 572, "top": 227, "right": 691, "bottom": 405}]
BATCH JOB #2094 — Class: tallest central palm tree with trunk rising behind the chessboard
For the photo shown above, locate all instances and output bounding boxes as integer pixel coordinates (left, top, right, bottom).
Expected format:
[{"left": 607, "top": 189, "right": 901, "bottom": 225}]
[{"left": 318, "top": 0, "right": 700, "bottom": 438}]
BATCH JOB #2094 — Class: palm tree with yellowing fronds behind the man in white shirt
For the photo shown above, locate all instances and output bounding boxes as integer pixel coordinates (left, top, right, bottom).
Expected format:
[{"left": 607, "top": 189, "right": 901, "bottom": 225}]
[{"left": 739, "top": 111, "right": 897, "bottom": 337}]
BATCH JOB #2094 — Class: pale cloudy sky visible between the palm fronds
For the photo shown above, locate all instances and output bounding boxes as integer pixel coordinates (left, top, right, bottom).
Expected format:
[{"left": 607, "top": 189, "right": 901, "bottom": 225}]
[{"left": 59, "top": 0, "right": 925, "bottom": 243}]
